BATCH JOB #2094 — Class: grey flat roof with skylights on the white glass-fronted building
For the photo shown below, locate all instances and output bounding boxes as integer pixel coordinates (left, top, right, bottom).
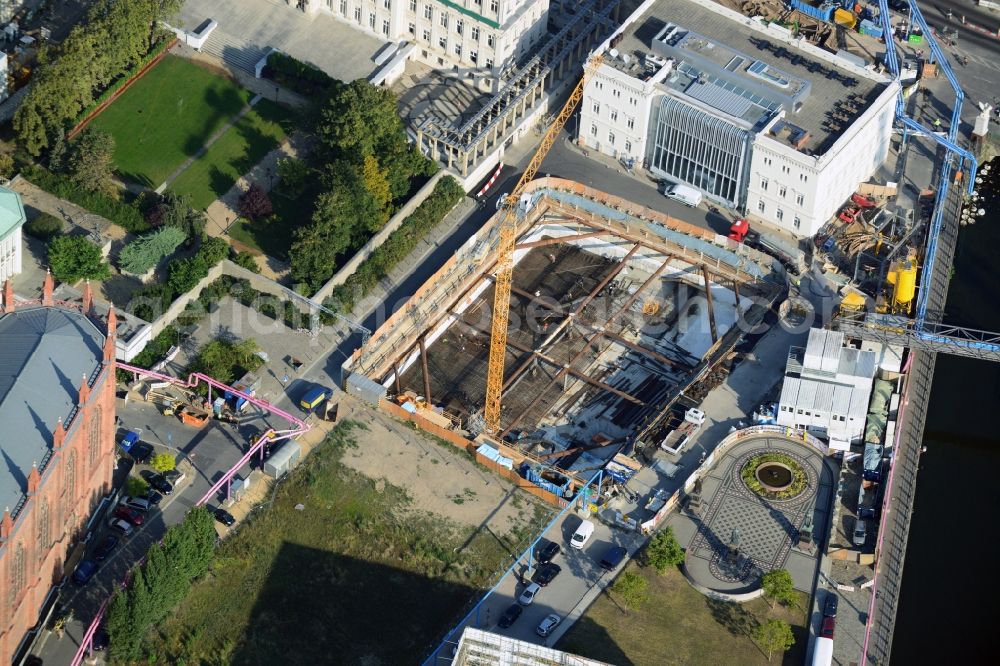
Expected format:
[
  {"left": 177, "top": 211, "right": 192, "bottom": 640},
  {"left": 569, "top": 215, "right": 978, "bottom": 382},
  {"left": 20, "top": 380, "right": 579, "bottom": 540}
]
[{"left": 604, "top": 0, "right": 885, "bottom": 154}]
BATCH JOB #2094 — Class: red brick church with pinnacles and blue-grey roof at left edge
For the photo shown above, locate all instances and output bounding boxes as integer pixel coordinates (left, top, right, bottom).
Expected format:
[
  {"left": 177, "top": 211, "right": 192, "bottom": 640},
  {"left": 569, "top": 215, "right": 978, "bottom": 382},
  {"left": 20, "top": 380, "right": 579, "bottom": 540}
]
[{"left": 0, "top": 275, "right": 117, "bottom": 664}]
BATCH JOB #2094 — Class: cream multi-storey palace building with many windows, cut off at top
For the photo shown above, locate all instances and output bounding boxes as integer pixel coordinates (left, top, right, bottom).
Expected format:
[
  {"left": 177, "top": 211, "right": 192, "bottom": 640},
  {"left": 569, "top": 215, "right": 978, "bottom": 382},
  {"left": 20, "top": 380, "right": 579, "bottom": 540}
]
[{"left": 303, "top": 0, "right": 549, "bottom": 81}]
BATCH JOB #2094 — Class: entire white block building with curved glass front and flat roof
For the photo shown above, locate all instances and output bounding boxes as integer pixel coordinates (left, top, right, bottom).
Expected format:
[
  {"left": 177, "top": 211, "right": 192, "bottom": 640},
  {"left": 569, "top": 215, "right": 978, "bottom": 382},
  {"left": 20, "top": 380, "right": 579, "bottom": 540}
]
[{"left": 577, "top": 0, "right": 899, "bottom": 236}]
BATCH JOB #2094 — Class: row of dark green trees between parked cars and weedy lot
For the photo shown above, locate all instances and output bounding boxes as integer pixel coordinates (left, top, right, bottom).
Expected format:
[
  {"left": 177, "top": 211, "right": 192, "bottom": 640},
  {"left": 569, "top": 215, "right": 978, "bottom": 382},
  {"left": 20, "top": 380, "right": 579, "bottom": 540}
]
[{"left": 107, "top": 508, "right": 218, "bottom": 663}]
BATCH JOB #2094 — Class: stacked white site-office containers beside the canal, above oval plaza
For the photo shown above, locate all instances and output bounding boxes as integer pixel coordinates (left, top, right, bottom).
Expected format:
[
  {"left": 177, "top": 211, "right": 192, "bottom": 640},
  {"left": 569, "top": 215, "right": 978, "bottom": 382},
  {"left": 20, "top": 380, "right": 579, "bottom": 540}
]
[{"left": 777, "top": 328, "right": 879, "bottom": 450}]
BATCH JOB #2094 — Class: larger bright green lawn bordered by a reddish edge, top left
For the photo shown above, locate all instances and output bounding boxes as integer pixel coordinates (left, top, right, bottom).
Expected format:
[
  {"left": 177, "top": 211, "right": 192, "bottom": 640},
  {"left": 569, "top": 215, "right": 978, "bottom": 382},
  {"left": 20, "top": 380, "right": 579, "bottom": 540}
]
[{"left": 90, "top": 55, "right": 252, "bottom": 188}]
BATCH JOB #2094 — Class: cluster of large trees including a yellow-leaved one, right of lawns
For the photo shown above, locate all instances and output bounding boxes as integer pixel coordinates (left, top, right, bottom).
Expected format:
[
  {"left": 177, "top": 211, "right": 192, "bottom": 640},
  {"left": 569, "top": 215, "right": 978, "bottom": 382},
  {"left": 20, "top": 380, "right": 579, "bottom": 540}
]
[{"left": 279, "top": 79, "right": 437, "bottom": 288}]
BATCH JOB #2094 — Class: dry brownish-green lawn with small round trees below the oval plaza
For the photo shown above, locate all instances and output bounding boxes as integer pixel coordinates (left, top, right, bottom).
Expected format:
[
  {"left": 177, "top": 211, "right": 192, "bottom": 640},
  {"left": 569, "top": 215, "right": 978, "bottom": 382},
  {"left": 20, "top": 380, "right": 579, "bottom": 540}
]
[{"left": 556, "top": 562, "right": 809, "bottom": 666}]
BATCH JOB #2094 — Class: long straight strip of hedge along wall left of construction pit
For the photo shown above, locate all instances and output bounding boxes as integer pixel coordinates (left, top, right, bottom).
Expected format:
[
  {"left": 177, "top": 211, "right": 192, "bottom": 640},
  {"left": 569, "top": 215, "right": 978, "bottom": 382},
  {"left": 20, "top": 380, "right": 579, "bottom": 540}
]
[{"left": 322, "top": 176, "right": 465, "bottom": 323}]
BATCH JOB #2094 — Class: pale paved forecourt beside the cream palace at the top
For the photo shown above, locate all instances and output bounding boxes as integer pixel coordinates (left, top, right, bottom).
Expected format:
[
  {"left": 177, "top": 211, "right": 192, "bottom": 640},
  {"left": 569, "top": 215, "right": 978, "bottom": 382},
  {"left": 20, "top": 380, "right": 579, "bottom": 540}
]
[{"left": 175, "top": 0, "right": 386, "bottom": 81}]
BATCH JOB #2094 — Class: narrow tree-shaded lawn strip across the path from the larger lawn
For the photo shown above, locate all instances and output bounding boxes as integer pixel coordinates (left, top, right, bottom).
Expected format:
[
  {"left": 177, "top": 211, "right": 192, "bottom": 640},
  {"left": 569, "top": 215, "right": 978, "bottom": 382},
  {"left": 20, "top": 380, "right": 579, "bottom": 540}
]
[{"left": 170, "top": 99, "right": 294, "bottom": 210}]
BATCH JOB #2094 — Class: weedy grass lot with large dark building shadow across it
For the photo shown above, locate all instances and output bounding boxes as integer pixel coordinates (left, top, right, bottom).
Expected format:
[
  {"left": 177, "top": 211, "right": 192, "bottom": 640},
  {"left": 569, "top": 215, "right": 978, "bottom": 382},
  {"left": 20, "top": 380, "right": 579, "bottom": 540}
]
[{"left": 143, "top": 422, "right": 550, "bottom": 665}]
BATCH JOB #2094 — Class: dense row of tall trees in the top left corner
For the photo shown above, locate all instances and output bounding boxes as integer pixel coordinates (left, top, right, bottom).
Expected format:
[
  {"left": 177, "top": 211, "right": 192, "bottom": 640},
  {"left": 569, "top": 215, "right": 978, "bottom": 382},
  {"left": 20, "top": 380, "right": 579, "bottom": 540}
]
[{"left": 14, "top": 0, "right": 184, "bottom": 155}]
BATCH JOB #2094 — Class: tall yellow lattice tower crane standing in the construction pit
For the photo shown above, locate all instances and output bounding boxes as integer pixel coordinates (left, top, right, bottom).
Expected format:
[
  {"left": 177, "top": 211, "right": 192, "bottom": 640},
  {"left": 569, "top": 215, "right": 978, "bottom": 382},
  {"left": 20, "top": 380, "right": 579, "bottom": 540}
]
[{"left": 483, "top": 55, "right": 601, "bottom": 435}]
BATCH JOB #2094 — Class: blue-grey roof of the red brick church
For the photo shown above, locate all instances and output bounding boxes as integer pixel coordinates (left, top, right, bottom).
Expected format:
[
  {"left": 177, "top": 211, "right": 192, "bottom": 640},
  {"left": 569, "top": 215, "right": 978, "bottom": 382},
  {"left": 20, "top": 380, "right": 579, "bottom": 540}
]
[{"left": 0, "top": 307, "right": 104, "bottom": 511}]
